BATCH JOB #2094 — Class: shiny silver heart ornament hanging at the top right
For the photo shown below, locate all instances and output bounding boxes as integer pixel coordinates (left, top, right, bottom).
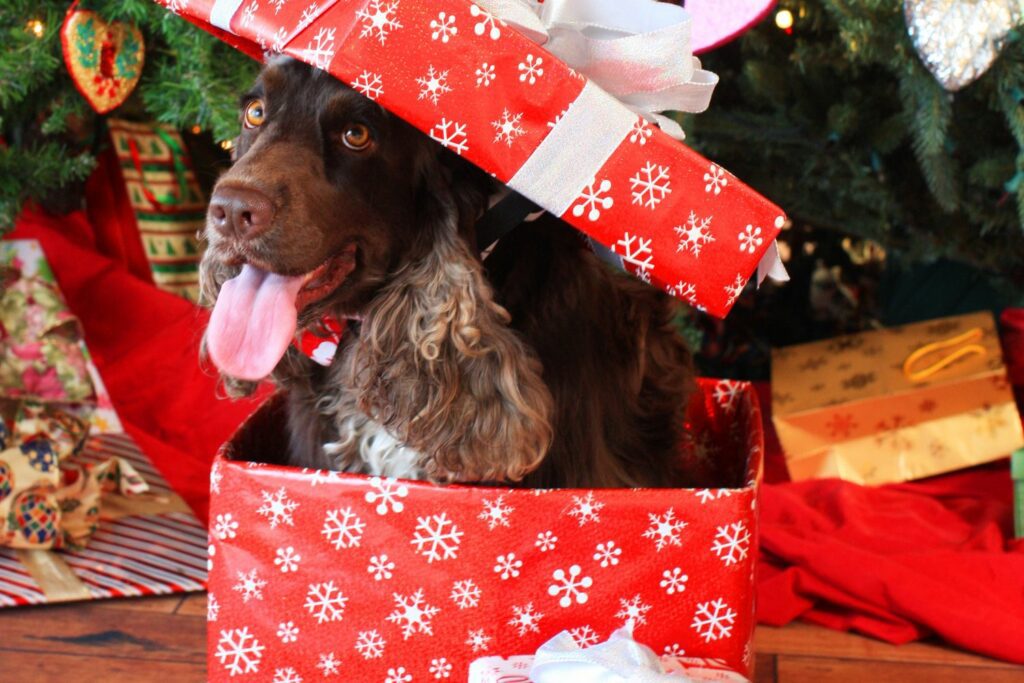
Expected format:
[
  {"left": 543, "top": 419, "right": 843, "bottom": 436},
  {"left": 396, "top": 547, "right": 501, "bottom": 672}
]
[{"left": 903, "top": 0, "right": 1024, "bottom": 92}]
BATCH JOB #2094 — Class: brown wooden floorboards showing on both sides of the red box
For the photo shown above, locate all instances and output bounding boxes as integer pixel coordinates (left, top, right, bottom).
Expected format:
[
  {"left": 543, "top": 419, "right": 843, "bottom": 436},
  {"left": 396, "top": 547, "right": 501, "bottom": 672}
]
[{"left": 0, "top": 594, "right": 1024, "bottom": 683}]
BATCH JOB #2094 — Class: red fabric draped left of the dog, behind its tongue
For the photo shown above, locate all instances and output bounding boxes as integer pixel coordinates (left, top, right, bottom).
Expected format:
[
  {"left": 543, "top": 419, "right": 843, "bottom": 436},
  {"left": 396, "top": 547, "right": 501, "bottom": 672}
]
[{"left": 11, "top": 206, "right": 268, "bottom": 519}]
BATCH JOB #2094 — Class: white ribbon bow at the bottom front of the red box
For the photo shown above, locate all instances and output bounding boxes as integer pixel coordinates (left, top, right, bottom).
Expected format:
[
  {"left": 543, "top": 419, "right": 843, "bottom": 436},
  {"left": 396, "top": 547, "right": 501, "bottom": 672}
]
[{"left": 529, "top": 627, "right": 687, "bottom": 683}]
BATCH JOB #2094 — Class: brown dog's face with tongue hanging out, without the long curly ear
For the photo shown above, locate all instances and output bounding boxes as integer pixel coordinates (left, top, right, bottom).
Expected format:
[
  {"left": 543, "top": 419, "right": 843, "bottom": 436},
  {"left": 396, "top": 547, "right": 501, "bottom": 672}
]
[{"left": 203, "top": 57, "right": 487, "bottom": 380}]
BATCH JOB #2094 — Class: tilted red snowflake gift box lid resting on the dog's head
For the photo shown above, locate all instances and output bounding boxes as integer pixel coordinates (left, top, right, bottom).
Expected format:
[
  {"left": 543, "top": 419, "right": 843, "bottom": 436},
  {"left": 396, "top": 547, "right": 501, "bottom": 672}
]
[{"left": 157, "top": 0, "right": 785, "bottom": 316}]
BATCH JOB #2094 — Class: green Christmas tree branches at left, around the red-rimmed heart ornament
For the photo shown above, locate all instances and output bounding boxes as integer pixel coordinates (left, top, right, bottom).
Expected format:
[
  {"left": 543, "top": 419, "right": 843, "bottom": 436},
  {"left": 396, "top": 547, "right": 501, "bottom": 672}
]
[{"left": 0, "top": 0, "right": 258, "bottom": 228}]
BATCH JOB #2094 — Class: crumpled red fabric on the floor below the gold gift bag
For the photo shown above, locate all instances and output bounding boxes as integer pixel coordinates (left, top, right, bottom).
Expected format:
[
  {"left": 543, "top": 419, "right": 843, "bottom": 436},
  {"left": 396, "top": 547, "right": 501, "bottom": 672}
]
[{"left": 758, "top": 387, "right": 1024, "bottom": 664}]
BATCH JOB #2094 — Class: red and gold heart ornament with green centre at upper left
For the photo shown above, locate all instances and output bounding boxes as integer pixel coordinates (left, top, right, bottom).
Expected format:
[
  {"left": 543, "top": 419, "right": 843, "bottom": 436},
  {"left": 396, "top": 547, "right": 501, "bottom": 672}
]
[{"left": 60, "top": 3, "right": 145, "bottom": 114}]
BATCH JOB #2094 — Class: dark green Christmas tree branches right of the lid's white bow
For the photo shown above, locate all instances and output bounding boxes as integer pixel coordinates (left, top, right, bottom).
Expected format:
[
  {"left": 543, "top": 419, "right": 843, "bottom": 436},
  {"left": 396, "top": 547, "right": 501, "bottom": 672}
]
[{"left": 687, "top": 0, "right": 1024, "bottom": 285}]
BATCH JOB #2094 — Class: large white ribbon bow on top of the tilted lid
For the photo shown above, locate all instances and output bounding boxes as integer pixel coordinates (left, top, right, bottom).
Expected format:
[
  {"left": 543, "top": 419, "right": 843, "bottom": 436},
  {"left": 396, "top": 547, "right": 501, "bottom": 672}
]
[{"left": 477, "top": 0, "right": 718, "bottom": 139}]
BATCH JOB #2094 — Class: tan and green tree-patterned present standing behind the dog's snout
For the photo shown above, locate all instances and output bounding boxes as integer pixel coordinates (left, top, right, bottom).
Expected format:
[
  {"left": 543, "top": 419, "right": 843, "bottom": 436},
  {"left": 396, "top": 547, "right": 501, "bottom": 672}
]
[{"left": 108, "top": 119, "right": 206, "bottom": 301}]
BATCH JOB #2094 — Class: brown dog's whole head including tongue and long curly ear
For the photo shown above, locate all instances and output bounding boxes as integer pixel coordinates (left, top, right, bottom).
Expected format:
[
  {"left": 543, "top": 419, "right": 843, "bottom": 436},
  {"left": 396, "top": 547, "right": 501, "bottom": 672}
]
[{"left": 201, "top": 57, "right": 550, "bottom": 478}]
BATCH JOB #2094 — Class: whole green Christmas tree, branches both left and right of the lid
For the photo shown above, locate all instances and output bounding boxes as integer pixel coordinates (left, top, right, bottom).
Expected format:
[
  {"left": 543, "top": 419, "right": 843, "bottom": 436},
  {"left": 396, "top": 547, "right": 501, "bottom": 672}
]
[{"left": 0, "top": 0, "right": 1024, "bottom": 284}]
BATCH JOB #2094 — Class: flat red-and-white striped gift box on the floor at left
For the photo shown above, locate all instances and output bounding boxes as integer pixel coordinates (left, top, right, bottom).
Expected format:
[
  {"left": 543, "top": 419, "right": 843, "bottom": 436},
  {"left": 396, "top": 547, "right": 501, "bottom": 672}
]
[{"left": 0, "top": 434, "right": 207, "bottom": 607}]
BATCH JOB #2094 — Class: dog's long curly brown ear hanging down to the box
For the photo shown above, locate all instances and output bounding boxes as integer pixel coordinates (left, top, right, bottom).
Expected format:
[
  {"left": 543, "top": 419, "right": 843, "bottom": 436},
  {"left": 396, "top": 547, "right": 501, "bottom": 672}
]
[{"left": 348, "top": 155, "right": 552, "bottom": 481}]
